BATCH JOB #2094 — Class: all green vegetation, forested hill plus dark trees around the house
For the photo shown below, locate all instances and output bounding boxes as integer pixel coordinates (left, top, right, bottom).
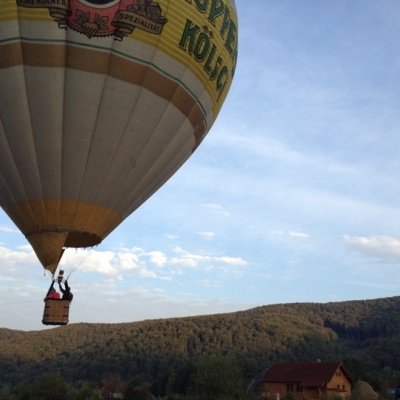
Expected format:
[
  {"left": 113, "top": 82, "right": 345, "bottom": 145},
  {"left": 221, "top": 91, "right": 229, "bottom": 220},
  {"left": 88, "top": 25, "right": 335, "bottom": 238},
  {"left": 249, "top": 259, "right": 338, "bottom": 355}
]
[{"left": 0, "top": 297, "right": 400, "bottom": 400}]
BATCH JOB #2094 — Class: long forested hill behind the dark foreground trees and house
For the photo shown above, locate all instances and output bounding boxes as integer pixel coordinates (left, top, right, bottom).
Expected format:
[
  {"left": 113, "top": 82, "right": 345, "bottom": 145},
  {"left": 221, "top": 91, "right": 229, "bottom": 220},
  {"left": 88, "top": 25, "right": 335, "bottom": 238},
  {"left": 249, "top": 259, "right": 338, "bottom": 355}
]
[{"left": 0, "top": 297, "right": 400, "bottom": 384}]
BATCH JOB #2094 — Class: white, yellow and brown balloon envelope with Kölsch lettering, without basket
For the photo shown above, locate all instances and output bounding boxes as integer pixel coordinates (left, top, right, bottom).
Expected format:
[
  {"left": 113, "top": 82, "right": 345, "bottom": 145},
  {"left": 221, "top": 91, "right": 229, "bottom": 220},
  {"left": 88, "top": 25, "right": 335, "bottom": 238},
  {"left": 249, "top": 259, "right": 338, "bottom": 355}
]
[{"left": 0, "top": 0, "right": 237, "bottom": 273}]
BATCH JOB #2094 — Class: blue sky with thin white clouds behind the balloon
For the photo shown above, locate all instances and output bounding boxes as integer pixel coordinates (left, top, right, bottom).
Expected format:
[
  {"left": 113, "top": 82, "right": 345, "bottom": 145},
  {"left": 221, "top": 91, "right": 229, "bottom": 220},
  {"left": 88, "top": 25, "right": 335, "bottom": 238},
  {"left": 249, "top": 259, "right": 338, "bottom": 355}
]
[{"left": 0, "top": 0, "right": 400, "bottom": 331}]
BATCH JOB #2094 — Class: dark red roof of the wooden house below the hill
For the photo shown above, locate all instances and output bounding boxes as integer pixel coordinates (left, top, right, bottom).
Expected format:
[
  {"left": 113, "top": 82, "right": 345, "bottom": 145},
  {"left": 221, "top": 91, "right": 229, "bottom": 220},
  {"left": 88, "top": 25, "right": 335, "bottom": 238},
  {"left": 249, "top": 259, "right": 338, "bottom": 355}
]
[{"left": 261, "top": 362, "right": 341, "bottom": 387}]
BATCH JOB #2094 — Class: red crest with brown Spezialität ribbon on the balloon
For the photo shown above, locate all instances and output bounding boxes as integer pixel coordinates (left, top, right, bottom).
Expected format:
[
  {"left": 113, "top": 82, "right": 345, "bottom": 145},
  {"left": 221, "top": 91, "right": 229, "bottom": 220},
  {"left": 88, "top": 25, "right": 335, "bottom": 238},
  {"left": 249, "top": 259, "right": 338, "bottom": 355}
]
[{"left": 17, "top": 0, "right": 168, "bottom": 40}]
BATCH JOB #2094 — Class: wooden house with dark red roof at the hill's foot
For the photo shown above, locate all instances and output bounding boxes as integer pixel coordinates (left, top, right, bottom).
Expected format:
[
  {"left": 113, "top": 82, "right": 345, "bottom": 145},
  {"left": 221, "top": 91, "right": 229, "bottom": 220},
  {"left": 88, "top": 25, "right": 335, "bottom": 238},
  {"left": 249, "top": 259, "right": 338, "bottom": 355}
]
[{"left": 251, "top": 360, "right": 353, "bottom": 400}]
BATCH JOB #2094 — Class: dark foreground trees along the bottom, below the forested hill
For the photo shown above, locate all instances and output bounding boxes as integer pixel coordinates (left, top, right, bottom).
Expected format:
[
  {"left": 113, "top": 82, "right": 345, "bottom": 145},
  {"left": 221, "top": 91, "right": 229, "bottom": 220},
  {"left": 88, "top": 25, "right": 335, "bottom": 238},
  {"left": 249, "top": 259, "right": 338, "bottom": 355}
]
[{"left": 0, "top": 356, "right": 400, "bottom": 400}]
